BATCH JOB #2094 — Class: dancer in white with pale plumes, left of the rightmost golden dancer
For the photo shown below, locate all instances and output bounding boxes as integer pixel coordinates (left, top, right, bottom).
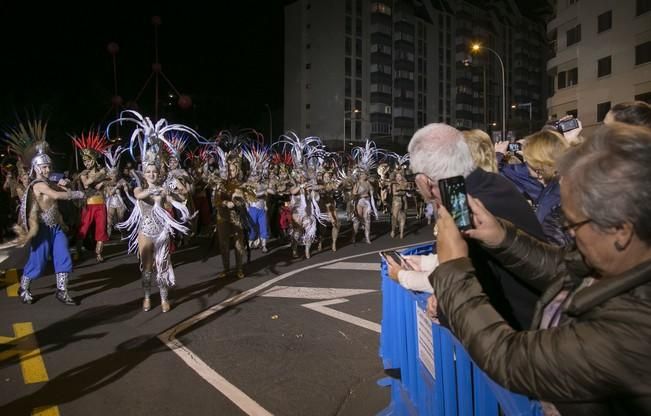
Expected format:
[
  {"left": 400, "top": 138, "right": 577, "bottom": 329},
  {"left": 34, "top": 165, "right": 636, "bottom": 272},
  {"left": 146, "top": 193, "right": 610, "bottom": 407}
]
[{"left": 351, "top": 140, "right": 379, "bottom": 244}]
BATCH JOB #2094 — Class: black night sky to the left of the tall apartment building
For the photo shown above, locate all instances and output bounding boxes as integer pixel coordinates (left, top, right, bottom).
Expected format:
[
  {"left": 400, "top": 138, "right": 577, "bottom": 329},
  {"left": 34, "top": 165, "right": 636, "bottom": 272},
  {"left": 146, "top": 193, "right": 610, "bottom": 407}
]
[{"left": 0, "top": 0, "right": 285, "bottom": 149}]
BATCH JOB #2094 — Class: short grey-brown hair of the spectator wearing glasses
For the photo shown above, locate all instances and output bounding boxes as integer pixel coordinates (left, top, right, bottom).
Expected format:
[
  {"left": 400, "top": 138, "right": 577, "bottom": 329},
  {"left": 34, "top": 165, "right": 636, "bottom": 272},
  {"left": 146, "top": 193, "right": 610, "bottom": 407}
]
[{"left": 557, "top": 122, "right": 651, "bottom": 244}]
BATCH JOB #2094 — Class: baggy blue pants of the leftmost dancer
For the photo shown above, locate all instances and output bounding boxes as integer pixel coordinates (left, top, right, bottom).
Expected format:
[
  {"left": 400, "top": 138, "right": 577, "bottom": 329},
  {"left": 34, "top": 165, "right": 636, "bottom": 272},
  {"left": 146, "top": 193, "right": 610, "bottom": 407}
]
[{"left": 23, "top": 223, "right": 72, "bottom": 280}]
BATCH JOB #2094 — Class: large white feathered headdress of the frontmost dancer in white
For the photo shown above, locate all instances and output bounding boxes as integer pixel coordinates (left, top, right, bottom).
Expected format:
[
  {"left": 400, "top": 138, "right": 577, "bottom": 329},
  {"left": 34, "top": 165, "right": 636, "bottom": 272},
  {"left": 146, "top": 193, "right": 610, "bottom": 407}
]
[{"left": 106, "top": 110, "right": 204, "bottom": 169}]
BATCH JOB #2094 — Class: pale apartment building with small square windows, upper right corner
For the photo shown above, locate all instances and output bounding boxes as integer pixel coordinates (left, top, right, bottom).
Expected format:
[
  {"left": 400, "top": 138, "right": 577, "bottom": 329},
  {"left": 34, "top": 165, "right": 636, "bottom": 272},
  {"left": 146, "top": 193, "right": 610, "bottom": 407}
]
[{"left": 547, "top": 0, "right": 651, "bottom": 134}]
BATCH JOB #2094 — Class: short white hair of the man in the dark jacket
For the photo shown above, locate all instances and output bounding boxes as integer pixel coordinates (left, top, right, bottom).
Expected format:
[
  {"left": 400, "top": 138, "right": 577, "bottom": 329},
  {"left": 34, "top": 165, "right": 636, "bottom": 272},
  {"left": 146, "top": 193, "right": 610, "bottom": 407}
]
[{"left": 408, "top": 123, "right": 476, "bottom": 181}]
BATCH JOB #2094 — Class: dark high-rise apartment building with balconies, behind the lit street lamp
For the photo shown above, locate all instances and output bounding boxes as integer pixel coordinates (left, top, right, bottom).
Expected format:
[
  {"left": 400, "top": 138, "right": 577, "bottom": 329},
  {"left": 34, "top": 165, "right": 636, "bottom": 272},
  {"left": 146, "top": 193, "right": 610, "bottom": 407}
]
[{"left": 284, "top": 0, "right": 546, "bottom": 151}]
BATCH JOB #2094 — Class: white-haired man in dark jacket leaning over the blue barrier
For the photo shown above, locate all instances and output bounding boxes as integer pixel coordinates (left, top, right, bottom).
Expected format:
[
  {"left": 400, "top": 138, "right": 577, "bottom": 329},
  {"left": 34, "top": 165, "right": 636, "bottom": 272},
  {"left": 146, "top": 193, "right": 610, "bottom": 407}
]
[{"left": 388, "top": 123, "right": 544, "bottom": 329}]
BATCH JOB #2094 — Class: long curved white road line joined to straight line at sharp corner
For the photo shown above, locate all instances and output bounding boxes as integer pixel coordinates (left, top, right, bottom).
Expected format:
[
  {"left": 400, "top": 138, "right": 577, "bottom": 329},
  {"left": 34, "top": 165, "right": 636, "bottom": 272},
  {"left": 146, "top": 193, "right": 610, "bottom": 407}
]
[{"left": 158, "top": 243, "right": 423, "bottom": 415}]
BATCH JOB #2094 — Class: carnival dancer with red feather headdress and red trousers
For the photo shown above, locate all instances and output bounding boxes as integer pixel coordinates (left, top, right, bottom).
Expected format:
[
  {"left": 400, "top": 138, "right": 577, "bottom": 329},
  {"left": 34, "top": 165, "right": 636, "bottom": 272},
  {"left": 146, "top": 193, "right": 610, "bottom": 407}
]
[{"left": 72, "top": 132, "right": 109, "bottom": 263}]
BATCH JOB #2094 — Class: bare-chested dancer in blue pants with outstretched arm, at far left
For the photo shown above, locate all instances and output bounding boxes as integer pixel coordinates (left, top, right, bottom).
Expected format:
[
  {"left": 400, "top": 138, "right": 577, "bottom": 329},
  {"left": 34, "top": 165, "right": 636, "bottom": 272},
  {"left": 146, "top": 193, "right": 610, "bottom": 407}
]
[{"left": 7, "top": 120, "right": 85, "bottom": 305}]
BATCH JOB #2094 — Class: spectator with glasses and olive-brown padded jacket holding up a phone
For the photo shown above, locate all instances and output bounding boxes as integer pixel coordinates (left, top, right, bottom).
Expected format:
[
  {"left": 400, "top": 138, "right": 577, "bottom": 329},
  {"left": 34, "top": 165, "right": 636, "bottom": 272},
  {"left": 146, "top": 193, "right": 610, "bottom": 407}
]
[{"left": 431, "top": 123, "right": 651, "bottom": 416}]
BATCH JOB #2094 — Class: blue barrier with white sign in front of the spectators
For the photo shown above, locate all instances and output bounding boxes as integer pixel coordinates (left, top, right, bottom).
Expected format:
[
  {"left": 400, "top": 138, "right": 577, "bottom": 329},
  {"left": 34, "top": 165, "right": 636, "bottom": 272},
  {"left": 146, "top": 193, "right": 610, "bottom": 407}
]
[{"left": 380, "top": 244, "right": 542, "bottom": 416}]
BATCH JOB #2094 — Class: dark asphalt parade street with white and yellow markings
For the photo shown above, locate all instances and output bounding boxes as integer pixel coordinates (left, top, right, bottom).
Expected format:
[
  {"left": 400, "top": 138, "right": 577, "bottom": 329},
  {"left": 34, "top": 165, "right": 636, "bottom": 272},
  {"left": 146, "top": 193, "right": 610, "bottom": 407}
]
[{"left": 0, "top": 218, "right": 432, "bottom": 416}]
